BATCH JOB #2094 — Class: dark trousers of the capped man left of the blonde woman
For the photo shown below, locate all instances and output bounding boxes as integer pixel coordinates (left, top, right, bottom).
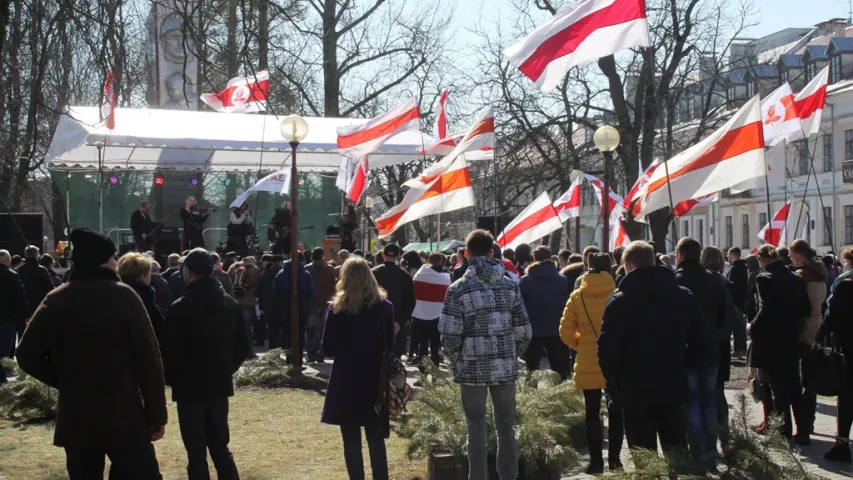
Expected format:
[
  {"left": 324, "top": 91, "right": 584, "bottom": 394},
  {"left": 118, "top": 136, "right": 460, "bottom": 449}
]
[{"left": 178, "top": 398, "right": 240, "bottom": 480}]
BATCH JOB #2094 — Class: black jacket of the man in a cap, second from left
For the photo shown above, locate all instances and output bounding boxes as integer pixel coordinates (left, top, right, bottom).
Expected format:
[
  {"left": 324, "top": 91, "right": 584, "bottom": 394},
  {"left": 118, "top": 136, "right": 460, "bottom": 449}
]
[{"left": 163, "top": 277, "right": 251, "bottom": 402}]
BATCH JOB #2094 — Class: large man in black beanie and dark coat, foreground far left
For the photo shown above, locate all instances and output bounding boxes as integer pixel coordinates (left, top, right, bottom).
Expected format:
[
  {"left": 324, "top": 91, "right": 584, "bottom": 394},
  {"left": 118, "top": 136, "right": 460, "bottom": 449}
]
[{"left": 17, "top": 228, "right": 167, "bottom": 479}]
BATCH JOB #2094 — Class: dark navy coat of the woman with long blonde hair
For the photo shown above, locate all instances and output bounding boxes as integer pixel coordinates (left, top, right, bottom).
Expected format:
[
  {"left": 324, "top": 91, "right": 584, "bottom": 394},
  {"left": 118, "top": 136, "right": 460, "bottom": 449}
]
[{"left": 322, "top": 300, "right": 394, "bottom": 426}]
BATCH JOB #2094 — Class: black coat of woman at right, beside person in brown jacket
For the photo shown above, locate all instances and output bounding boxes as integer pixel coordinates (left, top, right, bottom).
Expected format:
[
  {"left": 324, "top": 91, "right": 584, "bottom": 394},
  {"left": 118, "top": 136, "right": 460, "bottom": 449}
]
[{"left": 749, "top": 261, "right": 812, "bottom": 371}]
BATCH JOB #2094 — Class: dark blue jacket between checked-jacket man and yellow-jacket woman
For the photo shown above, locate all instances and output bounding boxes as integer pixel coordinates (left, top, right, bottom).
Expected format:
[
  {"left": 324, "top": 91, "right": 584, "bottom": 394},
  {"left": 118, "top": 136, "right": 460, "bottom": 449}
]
[{"left": 518, "top": 262, "right": 572, "bottom": 338}]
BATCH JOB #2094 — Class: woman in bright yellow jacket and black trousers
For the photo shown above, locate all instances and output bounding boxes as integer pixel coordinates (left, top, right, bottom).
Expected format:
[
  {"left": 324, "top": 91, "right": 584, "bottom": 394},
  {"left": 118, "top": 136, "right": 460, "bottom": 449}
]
[{"left": 560, "top": 253, "right": 623, "bottom": 475}]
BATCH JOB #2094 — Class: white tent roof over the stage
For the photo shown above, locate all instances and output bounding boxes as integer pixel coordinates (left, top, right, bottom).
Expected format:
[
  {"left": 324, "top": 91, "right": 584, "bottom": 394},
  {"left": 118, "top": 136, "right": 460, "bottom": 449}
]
[{"left": 46, "top": 107, "right": 433, "bottom": 172}]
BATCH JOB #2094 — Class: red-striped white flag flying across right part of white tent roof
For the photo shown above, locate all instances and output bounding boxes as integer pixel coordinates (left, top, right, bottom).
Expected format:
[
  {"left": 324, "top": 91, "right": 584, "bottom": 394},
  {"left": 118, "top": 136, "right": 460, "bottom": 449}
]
[{"left": 338, "top": 97, "right": 421, "bottom": 158}]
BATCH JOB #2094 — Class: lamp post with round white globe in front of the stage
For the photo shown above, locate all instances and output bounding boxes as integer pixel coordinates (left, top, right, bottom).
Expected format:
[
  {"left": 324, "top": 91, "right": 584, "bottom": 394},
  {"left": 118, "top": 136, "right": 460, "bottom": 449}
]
[{"left": 281, "top": 115, "right": 308, "bottom": 373}]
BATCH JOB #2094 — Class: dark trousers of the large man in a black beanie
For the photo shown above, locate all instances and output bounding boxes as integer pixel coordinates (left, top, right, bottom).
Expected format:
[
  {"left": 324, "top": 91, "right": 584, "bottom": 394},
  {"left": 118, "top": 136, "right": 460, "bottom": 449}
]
[{"left": 65, "top": 443, "right": 163, "bottom": 480}]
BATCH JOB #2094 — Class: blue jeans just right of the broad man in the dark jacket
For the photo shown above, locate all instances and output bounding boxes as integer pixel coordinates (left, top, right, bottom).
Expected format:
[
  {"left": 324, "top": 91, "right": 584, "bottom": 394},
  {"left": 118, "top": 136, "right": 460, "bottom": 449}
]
[{"left": 687, "top": 365, "right": 718, "bottom": 460}]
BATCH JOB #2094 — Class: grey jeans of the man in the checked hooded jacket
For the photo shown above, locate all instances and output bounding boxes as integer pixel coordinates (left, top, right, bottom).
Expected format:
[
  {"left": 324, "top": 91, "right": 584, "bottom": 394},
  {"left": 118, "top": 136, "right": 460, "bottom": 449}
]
[{"left": 461, "top": 383, "right": 518, "bottom": 480}]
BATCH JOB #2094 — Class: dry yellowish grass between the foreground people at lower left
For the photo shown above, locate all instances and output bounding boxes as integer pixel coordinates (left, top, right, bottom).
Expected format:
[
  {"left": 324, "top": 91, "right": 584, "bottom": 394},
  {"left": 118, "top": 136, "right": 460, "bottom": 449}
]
[{"left": 0, "top": 389, "right": 426, "bottom": 480}]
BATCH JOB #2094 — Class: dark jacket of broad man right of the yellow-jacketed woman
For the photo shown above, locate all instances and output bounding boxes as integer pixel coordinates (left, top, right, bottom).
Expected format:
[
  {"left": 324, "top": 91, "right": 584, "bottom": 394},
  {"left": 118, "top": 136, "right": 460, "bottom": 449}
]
[{"left": 598, "top": 266, "right": 709, "bottom": 408}]
